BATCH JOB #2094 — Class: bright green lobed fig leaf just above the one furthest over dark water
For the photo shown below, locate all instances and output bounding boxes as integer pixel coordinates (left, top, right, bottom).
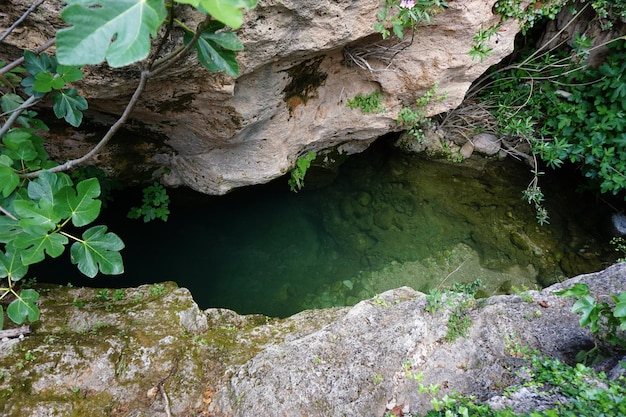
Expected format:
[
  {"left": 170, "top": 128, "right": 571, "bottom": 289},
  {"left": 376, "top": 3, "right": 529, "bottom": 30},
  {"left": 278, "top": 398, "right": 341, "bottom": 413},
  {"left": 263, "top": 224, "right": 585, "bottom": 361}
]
[{"left": 55, "top": 178, "right": 102, "bottom": 226}]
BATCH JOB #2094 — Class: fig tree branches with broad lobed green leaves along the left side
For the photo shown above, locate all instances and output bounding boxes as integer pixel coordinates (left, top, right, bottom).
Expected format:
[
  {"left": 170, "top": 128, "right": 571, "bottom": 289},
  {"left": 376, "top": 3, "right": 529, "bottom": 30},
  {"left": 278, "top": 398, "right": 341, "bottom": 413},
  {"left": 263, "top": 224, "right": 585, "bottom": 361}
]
[{"left": 0, "top": 0, "right": 256, "bottom": 328}]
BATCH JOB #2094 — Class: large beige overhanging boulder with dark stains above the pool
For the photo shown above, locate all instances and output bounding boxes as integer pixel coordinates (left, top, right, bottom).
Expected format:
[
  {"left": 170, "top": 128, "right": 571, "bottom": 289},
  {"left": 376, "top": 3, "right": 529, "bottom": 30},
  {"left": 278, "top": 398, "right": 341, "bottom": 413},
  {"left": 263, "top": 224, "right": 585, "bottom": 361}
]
[{"left": 0, "top": 0, "right": 518, "bottom": 194}]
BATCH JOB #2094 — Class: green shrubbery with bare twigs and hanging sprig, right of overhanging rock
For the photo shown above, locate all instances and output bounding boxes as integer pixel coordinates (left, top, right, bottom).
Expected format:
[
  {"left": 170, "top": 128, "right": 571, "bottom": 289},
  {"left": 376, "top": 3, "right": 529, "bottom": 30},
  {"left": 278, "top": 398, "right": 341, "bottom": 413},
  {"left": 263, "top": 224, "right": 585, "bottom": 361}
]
[{"left": 468, "top": 6, "right": 626, "bottom": 224}]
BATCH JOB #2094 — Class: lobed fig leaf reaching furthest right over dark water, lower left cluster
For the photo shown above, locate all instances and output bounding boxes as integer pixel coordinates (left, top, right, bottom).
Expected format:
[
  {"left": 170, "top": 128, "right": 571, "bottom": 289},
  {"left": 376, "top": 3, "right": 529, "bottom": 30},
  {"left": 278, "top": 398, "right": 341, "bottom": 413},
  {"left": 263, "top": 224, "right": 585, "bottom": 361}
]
[{"left": 70, "top": 226, "right": 124, "bottom": 278}]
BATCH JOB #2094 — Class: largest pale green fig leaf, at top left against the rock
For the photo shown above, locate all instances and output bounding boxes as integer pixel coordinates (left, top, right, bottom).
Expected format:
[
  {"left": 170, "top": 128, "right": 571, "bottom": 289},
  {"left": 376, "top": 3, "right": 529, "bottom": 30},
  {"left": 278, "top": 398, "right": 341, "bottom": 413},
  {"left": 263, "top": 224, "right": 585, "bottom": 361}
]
[{"left": 57, "top": 0, "right": 167, "bottom": 67}]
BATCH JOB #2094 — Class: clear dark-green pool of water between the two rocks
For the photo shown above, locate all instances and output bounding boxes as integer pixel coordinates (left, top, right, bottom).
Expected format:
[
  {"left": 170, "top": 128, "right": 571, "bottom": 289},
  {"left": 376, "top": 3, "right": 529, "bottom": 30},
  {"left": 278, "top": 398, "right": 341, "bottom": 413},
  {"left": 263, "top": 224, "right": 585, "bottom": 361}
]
[{"left": 35, "top": 140, "right": 615, "bottom": 316}]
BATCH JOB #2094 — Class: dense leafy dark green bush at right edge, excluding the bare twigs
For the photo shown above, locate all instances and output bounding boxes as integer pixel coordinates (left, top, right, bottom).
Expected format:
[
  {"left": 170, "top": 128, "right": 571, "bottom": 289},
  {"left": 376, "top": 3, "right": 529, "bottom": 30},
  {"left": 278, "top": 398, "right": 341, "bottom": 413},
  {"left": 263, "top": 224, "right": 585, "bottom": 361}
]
[{"left": 533, "top": 41, "right": 626, "bottom": 198}]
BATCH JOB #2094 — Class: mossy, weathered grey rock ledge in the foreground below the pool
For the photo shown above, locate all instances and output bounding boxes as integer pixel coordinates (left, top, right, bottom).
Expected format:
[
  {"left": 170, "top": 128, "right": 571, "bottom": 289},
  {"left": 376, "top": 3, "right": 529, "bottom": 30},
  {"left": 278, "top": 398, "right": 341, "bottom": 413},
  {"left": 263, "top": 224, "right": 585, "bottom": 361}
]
[{"left": 0, "top": 264, "right": 626, "bottom": 417}]
